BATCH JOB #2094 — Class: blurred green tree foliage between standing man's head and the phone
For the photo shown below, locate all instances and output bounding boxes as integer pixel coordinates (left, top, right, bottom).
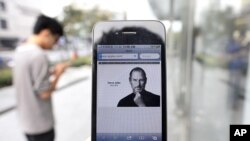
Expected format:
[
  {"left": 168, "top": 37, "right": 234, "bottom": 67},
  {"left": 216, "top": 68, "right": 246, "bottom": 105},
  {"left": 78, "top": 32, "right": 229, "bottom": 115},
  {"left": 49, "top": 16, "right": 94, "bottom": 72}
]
[{"left": 62, "top": 5, "right": 113, "bottom": 36}]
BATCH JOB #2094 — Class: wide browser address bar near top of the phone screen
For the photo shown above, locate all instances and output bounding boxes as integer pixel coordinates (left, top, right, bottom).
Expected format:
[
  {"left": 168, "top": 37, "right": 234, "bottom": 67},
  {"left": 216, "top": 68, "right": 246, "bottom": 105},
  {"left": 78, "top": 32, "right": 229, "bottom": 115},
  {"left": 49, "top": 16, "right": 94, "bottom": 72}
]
[{"left": 100, "top": 53, "right": 138, "bottom": 60}]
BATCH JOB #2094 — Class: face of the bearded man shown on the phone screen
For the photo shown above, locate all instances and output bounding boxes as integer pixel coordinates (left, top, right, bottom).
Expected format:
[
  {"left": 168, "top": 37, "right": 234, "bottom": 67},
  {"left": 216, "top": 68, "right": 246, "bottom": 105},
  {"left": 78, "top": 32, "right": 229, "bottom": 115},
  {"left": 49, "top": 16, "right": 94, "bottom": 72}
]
[{"left": 130, "top": 71, "right": 147, "bottom": 94}]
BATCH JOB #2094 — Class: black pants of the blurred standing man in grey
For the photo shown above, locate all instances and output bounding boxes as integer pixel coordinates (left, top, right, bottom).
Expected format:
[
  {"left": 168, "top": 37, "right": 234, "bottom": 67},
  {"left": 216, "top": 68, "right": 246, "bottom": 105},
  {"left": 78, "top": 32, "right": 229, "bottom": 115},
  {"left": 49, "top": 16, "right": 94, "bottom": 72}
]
[{"left": 26, "top": 129, "right": 55, "bottom": 141}]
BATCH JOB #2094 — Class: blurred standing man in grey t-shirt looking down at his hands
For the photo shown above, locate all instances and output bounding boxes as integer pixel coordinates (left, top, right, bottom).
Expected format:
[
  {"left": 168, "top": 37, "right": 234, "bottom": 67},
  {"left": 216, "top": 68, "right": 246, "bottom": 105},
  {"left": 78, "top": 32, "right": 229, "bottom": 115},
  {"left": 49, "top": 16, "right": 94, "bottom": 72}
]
[{"left": 13, "top": 15, "right": 68, "bottom": 141}]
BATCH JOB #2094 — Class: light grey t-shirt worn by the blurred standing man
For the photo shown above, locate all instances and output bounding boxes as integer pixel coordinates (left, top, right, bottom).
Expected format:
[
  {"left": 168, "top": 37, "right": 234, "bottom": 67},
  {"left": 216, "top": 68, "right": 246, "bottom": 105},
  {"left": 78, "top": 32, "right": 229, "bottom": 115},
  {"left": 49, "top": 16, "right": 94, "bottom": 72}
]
[{"left": 13, "top": 44, "right": 54, "bottom": 134}]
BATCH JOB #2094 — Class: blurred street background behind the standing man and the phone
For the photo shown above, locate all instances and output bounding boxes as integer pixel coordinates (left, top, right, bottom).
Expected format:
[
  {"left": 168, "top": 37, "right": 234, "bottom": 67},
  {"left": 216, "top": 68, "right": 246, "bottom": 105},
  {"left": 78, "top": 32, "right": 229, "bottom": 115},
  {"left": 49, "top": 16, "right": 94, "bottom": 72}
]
[{"left": 0, "top": 0, "right": 250, "bottom": 141}]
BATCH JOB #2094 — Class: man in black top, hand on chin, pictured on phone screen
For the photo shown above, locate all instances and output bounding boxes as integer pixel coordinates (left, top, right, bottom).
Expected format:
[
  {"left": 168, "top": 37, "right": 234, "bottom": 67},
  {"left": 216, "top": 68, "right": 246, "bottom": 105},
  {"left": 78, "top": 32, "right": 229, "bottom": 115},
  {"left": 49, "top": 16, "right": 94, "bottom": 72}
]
[{"left": 117, "top": 67, "right": 160, "bottom": 107}]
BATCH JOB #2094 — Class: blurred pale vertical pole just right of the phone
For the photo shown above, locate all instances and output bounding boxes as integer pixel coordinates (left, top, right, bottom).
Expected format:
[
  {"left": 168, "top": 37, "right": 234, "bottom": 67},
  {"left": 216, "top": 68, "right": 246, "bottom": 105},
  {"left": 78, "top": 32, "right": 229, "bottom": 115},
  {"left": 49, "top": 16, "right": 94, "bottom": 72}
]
[{"left": 180, "top": 0, "right": 195, "bottom": 141}]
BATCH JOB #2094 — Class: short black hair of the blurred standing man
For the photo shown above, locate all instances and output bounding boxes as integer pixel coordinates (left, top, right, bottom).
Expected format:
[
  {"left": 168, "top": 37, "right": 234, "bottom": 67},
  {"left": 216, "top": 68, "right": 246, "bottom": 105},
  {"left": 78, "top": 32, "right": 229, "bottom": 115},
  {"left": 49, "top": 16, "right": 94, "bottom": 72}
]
[{"left": 33, "top": 15, "right": 63, "bottom": 36}]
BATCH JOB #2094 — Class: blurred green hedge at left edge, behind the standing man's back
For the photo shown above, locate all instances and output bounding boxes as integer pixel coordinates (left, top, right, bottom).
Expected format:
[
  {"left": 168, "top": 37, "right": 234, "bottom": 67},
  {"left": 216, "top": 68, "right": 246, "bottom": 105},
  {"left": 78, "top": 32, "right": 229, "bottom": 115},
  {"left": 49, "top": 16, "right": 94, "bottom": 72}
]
[{"left": 0, "top": 68, "right": 12, "bottom": 88}]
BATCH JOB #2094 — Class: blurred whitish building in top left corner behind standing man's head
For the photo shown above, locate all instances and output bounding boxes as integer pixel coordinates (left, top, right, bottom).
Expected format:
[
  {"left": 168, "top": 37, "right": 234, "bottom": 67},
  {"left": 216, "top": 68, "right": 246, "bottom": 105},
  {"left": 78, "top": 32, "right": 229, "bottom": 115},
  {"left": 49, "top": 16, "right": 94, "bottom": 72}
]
[{"left": 0, "top": 0, "right": 40, "bottom": 49}]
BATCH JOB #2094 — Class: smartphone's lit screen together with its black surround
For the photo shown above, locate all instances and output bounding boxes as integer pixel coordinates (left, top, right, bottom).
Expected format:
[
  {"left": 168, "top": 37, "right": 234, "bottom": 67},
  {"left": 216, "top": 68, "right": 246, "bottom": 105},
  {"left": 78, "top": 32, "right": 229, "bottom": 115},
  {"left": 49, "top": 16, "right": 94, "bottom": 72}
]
[{"left": 92, "top": 21, "right": 166, "bottom": 141}]
